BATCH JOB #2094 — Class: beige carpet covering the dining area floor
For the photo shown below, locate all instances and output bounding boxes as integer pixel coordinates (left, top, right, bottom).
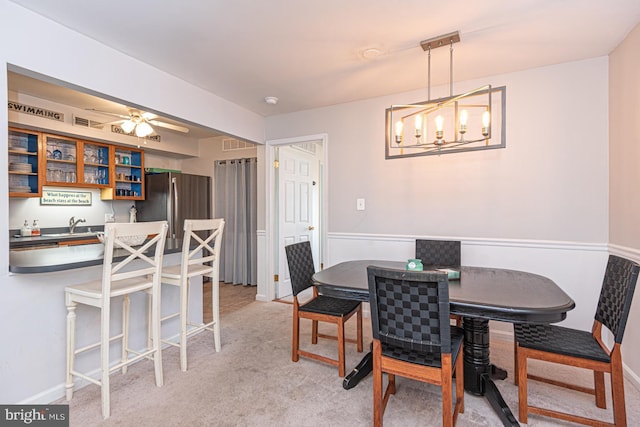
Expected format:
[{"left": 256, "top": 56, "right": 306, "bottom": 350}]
[{"left": 56, "top": 302, "right": 640, "bottom": 427}]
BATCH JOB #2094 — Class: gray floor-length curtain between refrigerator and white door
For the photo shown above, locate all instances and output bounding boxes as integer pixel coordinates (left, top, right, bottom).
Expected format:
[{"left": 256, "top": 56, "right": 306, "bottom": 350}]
[{"left": 214, "top": 158, "right": 258, "bottom": 286}]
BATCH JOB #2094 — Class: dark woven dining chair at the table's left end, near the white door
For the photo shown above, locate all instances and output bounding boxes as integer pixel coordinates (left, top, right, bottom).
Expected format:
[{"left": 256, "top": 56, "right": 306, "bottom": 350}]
[{"left": 284, "top": 242, "right": 363, "bottom": 377}]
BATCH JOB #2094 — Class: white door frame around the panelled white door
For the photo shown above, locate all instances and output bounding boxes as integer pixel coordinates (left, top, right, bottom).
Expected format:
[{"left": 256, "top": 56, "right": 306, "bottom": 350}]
[{"left": 265, "top": 133, "right": 329, "bottom": 301}]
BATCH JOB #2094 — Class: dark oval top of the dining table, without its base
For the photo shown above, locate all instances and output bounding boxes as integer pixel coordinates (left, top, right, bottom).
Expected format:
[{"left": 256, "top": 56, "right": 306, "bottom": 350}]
[{"left": 313, "top": 260, "right": 575, "bottom": 323}]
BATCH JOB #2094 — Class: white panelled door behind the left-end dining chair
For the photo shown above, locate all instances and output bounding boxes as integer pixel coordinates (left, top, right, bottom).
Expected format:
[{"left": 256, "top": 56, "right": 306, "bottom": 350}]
[{"left": 276, "top": 146, "right": 320, "bottom": 298}]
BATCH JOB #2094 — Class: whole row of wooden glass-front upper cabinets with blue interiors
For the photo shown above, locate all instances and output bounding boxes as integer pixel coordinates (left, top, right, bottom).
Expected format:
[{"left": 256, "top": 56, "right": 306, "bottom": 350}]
[{"left": 9, "top": 128, "right": 144, "bottom": 200}]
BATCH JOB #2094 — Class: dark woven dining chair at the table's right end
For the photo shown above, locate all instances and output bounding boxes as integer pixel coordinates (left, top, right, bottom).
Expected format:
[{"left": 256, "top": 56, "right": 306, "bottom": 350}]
[{"left": 514, "top": 255, "right": 640, "bottom": 426}]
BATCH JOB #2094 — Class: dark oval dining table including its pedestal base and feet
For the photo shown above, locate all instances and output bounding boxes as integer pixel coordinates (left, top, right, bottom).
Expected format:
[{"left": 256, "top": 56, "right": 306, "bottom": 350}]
[{"left": 313, "top": 260, "right": 575, "bottom": 426}]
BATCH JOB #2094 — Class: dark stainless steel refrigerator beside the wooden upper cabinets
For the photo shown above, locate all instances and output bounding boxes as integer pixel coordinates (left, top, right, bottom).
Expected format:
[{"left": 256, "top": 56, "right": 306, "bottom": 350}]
[{"left": 136, "top": 172, "right": 211, "bottom": 239}]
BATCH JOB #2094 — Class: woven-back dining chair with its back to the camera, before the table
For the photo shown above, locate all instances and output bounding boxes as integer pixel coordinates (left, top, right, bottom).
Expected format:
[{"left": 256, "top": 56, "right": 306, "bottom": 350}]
[{"left": 367, "top": 266, "right": 464, "bottom": 426}]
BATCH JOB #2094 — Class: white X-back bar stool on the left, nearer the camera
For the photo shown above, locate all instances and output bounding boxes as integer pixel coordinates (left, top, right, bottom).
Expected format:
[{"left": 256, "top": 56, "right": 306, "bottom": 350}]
[{"left": 65, "top": 221, "right": 168, "bottom": 419}]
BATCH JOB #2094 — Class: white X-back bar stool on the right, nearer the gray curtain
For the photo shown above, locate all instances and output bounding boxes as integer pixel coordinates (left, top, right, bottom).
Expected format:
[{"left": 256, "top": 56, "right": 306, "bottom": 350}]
[{"left": 161, "top": 218, "right": 224, "bottom": 371}]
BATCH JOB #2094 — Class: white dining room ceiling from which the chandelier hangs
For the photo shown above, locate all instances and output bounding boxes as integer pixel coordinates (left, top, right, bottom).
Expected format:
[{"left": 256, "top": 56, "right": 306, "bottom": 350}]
[{"left": 5, "top": 0, "right": 640, "bottom": 121}]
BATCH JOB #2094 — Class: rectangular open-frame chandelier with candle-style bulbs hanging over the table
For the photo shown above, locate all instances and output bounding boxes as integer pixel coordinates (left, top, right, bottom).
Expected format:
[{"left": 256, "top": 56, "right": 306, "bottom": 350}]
[{"left": 385, "top": 31, "right": 506, "bottom": 159}]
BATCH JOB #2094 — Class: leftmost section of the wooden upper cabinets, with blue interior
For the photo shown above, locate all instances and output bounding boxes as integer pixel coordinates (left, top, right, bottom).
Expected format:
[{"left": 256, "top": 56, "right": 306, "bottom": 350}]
[{"left": 8, "top": 128, "right": 43, "bottom": 197}]
